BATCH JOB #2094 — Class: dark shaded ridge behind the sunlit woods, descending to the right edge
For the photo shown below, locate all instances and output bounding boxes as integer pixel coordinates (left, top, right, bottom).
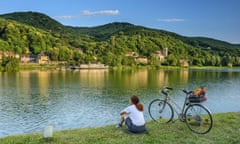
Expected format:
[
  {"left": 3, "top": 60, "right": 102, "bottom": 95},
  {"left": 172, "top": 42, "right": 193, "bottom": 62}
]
[{"left": 75, "top": 22, "right": 240, "bottom": 56}]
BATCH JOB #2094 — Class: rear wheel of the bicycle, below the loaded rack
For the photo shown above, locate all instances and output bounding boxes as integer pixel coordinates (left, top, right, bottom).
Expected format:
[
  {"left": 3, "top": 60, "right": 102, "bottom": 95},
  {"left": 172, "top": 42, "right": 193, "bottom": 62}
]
[{"left": 184, "top": 104, "right": 213, "bottom": 134}]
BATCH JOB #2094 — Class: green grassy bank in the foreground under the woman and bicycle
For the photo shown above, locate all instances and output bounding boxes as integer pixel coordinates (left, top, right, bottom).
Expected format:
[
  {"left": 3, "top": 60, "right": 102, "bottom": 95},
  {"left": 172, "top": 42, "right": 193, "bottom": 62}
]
[{"left": 0, "top": 112, "right": 240, "bottom": 144}]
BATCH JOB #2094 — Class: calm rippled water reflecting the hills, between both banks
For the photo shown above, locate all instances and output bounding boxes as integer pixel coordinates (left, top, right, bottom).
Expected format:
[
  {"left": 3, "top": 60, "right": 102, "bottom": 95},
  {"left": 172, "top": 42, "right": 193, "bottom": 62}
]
[{"left": 0, "top": 68, "right": 240, "bottom": 137}]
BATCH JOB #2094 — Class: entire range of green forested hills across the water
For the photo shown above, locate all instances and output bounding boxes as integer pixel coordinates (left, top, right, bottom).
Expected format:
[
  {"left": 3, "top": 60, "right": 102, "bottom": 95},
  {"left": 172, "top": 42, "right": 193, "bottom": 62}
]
[{"left": 0, "top": 12, "right": 240, "bottom": 66}]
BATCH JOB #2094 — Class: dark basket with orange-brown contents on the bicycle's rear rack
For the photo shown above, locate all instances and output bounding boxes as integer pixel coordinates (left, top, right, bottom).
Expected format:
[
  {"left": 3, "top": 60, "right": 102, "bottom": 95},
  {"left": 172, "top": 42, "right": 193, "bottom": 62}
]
[{"left": 189, "top": 87, "right": 207, "bottom": 103}]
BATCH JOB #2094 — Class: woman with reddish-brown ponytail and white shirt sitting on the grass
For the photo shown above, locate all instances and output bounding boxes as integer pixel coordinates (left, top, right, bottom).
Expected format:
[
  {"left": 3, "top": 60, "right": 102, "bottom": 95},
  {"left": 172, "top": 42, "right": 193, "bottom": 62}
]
[{"left": 117, "top": 96, "right": 147, "bottom": 133}]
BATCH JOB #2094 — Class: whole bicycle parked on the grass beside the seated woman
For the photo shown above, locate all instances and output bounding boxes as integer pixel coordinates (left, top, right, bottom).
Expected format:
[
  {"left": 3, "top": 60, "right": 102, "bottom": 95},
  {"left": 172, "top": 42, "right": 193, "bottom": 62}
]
[{"left": 148, "top": 87, "right": 213, "bottom": 134}]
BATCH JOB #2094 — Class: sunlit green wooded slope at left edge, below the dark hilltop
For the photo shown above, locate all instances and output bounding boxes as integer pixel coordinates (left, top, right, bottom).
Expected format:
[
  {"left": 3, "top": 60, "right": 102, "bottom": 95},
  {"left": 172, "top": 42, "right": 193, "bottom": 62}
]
[{"left": 0, "top": 18, "right": 74, "bottom": 54}]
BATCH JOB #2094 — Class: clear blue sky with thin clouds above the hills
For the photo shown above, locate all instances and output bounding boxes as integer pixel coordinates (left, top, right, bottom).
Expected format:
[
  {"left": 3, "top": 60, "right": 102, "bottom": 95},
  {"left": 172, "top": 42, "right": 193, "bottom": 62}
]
[{"left": 0, "top": 0, "right": 240, "bottom": 44}]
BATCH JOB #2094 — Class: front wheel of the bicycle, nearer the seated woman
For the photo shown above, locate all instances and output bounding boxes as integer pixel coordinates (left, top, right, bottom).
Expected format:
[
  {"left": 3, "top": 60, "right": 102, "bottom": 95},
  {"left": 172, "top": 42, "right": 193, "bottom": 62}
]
[{"left": 148, "top": 99, "right": 174, "bottom": 123}]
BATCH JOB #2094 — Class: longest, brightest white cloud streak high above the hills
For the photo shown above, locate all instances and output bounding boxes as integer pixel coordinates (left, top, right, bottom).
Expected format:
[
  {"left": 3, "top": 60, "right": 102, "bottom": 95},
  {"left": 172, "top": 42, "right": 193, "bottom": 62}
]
[{"left": 82, "top": 10, "right": 119, "bottom": 16}]
